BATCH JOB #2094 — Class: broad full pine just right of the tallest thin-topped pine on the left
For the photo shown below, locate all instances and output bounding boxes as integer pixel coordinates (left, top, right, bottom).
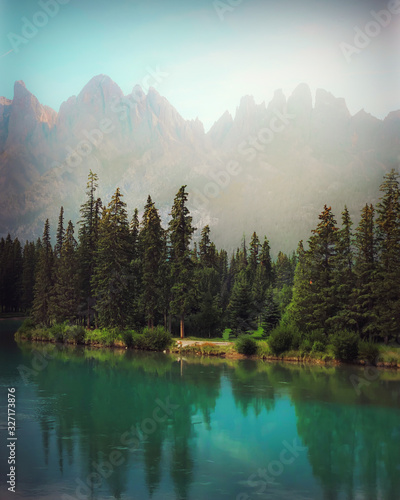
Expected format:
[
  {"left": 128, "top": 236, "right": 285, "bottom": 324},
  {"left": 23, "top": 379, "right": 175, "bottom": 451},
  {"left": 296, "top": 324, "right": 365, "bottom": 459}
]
[{"left": 92, "top": 188, "right": 131, "bottom": 327}]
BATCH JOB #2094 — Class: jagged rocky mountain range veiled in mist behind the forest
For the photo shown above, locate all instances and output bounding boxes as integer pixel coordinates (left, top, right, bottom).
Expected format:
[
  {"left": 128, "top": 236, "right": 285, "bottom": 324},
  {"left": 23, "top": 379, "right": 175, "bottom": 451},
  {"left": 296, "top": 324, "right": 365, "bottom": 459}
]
[{"left": 0, "top": 75, "right": 400, "bottom": 254}]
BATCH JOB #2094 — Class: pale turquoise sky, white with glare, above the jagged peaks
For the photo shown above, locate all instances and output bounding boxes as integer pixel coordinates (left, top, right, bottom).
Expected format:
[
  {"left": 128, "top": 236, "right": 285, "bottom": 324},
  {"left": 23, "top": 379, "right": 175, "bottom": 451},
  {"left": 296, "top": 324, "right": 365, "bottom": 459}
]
[{"left": 0, "top": 0, "right": 400, "bottom": 130}]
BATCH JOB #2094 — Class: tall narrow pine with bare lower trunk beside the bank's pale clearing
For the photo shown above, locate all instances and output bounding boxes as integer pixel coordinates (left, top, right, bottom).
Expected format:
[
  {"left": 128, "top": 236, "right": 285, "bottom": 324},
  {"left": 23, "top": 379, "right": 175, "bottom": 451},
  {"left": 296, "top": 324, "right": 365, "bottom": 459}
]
[{"left": 169, "top": 186, "right": 195, "bottom": 338}]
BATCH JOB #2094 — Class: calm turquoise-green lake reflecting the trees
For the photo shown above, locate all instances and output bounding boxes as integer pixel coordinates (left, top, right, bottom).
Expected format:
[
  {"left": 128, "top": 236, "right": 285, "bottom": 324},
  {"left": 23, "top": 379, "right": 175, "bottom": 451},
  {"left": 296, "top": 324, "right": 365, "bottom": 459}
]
[{"left": 0, "top": 321, "right": 400, "bottom": 500}]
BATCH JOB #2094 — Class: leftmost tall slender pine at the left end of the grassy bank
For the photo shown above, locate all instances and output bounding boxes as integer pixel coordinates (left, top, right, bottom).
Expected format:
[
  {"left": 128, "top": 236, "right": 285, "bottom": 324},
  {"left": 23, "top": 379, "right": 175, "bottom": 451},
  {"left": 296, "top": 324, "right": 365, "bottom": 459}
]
[{"left": 32, "top": 219, "right": 54, "bottom": 326}]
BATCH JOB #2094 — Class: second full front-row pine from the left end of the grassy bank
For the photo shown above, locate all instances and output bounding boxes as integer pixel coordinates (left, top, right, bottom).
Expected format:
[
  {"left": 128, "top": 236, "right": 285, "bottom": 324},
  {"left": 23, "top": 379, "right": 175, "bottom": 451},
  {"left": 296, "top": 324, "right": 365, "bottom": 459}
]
[{"left": 49, "top": 221, "right": 80, "bottom": 323}]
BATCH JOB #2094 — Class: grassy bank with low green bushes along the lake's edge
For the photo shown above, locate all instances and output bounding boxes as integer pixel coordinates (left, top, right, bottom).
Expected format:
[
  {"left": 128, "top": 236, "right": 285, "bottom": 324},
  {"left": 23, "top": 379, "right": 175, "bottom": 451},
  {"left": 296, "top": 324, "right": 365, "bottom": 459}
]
[{"left": 15, "top": 319, "right": 400, "bottom": 368}]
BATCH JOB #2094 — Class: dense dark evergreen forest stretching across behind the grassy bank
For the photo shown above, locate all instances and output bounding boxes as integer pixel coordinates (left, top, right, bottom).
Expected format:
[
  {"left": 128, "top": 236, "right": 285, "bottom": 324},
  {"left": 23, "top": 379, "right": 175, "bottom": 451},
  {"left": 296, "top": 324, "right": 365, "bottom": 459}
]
[{"left": 0, "top": 170, "right": 400, "bottom": 342}]
